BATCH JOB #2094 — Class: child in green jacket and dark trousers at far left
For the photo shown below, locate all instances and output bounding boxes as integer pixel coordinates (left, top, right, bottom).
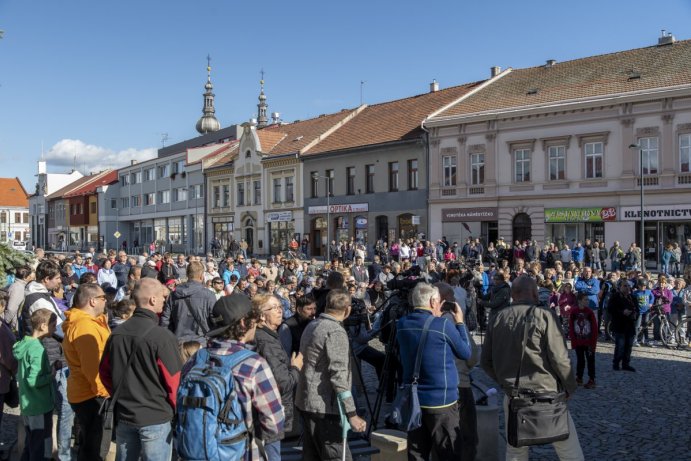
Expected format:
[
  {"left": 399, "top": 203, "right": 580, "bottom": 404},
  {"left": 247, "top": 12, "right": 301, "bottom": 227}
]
[{"left": 12, "top": 309, "right": 58, "bottom": 461}]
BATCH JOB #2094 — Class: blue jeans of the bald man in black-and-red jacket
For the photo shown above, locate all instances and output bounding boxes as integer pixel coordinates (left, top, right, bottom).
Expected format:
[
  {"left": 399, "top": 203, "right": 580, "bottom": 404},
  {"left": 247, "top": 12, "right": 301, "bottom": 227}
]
[{"left": 115, "top": 421, "right": 173, "bottom": 461}]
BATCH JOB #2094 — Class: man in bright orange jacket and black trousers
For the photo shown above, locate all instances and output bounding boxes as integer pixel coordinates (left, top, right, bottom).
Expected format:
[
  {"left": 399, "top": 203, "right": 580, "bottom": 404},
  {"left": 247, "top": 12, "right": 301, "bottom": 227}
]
[{"left": 62, "top": 283, "right": 110, "bottom": 461}]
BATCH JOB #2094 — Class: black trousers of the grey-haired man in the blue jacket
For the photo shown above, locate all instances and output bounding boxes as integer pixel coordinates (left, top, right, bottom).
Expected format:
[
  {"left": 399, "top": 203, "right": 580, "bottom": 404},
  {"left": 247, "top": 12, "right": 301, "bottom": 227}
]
[{"left": 408, "top": 403, "right": 461, "bottom": 461}]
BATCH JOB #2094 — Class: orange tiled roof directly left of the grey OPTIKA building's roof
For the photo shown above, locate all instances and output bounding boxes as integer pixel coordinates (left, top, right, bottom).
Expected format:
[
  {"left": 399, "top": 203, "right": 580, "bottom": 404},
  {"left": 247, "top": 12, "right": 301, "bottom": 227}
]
[{"left": 257, "top": 108, "right": 361, "bottom": 155}]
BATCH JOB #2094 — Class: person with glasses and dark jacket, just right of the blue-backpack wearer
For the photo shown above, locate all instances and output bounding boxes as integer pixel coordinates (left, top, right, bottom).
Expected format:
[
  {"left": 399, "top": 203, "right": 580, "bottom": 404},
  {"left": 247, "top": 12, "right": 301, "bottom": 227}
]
[{"left": 252, "top": 294, "right": 302, "bottom": 452}]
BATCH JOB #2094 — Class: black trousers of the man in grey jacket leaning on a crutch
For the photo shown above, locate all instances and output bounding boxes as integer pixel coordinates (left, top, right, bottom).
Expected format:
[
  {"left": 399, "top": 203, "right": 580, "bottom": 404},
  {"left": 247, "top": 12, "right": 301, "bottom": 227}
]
[{"left": 302, "top": 413, "right": 353, "bottom": 461}]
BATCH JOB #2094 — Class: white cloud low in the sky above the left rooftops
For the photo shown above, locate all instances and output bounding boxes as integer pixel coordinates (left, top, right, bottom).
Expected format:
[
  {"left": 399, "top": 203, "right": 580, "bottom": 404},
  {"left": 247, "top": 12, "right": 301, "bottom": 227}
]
[{"left": 44, "top": 139, "right": 158, "bottom": 174}]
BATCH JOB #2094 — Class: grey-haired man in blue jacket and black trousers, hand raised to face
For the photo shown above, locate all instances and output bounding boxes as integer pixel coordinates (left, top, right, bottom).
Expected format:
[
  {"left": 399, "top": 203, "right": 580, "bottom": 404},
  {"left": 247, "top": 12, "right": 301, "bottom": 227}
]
[{"left": 396, "top": 283, "right": 471, "bottom": 460}]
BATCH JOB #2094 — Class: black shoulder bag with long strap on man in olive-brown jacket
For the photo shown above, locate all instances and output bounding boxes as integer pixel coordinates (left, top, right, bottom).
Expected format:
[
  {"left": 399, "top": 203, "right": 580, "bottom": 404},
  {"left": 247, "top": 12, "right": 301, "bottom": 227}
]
[{"left": 507, "top": 306, "right": 569, "bottom": 447}]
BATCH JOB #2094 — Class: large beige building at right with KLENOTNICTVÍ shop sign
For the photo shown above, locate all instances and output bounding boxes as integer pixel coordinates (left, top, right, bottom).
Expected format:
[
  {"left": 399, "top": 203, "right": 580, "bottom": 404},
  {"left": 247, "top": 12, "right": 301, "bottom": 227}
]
[{"left": 424, "top": 36, "right": 691, "bottom": 267}]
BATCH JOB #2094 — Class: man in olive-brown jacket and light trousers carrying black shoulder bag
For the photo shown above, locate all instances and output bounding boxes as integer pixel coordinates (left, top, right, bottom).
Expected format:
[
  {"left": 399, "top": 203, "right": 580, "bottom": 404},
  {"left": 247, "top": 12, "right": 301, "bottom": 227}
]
[{"left": 480, "top": 275, "right": 584, "bottom": 460}]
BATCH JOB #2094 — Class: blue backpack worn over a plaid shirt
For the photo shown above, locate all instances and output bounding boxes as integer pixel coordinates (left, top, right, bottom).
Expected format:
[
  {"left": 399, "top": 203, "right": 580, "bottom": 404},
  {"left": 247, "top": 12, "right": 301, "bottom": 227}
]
[{"left": 175, "top": 349, "right": 256, "bottom": 461}]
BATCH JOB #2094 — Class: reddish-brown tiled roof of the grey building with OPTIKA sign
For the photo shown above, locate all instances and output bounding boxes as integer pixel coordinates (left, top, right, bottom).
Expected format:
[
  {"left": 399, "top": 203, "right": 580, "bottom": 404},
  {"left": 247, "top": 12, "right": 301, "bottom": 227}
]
[{"left": 306, "top": 82, "right": 483, "bottom": 155}]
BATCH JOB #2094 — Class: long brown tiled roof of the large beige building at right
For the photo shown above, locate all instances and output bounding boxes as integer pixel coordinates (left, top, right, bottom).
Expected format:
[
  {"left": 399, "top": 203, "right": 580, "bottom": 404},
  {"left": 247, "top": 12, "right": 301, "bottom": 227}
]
[{"left": 434, "top": 40, "right": 691, "bottom": 119}]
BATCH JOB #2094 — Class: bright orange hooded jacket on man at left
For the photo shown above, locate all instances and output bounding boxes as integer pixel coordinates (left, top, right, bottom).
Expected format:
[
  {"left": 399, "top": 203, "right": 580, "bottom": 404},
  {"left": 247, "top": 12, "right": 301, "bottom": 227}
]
[{"left": 62, "top": 308, "right": 110, "bottom": 403}]
